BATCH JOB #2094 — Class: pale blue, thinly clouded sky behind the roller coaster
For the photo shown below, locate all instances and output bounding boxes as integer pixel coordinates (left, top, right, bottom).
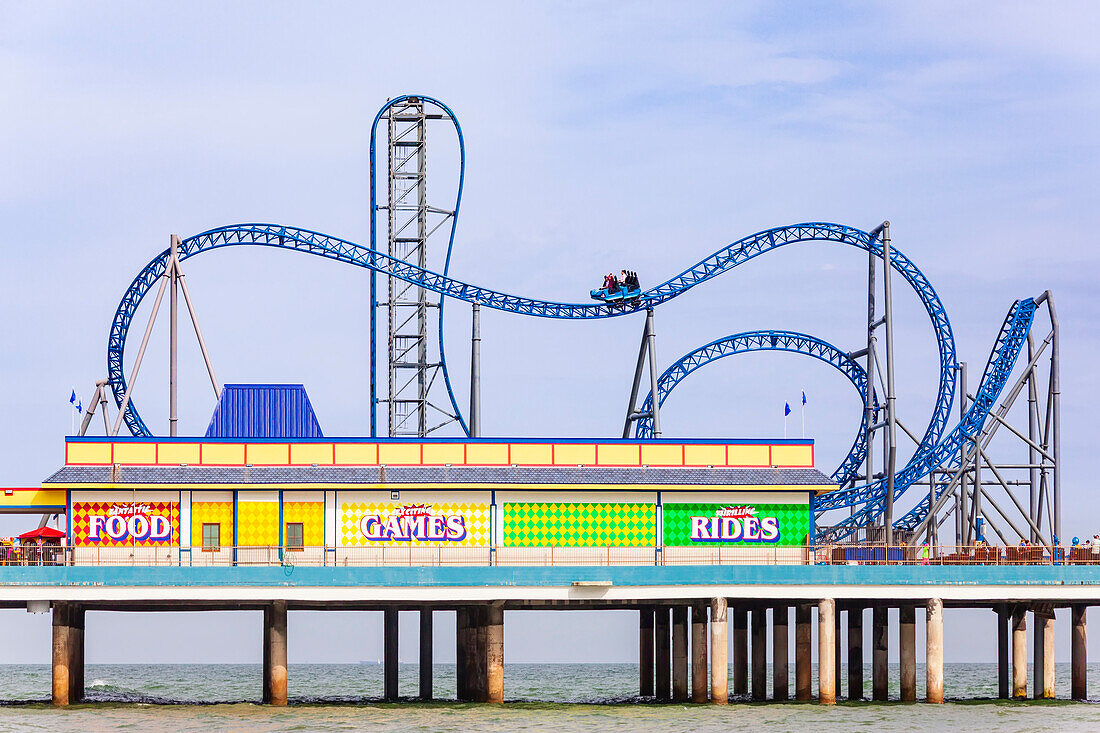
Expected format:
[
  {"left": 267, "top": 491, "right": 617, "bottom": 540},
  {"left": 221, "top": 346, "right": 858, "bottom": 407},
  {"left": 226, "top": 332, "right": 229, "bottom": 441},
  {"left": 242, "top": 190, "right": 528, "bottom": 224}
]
[{"left": 0, "top": 1, "right": 1100, "bottom": 661}]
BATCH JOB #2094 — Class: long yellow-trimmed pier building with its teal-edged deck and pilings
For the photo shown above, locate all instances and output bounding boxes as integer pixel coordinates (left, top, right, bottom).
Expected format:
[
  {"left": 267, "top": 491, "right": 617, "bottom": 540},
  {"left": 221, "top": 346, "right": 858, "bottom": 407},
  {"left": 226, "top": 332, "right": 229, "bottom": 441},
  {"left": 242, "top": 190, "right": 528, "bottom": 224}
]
[{"left": 0, "top": 436, "right": 1100, "bottom": 704}]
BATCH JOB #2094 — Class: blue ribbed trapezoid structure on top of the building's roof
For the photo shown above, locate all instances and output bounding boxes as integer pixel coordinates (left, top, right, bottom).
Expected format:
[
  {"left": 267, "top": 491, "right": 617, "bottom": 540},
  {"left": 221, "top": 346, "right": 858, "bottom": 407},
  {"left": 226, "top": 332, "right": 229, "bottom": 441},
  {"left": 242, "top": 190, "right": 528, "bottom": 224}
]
[{"left": 206, "top": 384, "right": 325, "bottom": 438}]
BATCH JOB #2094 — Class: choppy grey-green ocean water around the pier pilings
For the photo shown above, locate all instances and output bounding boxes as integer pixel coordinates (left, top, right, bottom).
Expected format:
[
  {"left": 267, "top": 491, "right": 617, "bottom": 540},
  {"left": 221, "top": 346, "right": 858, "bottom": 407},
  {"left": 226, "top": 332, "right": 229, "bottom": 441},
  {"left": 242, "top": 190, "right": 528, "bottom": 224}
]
[{"left": 0, "top": 664, "right": 1100, "bottom": 733}]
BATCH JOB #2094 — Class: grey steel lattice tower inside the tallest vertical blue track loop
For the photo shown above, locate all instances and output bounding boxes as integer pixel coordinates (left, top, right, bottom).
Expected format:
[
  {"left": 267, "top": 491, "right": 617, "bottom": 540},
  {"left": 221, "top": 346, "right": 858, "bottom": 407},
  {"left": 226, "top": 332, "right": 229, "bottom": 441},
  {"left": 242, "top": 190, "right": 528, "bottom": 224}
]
[{"left": 380, "top": 97, "right": 455, "bottom": 437}]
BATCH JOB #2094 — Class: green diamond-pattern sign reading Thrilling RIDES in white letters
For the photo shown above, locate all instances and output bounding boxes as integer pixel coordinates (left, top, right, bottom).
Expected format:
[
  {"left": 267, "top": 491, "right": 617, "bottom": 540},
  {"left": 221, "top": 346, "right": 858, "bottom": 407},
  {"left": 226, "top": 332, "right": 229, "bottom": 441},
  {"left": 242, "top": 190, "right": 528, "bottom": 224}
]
[{"left": 663, "top": 504, "right": 810, "bottom": 547}]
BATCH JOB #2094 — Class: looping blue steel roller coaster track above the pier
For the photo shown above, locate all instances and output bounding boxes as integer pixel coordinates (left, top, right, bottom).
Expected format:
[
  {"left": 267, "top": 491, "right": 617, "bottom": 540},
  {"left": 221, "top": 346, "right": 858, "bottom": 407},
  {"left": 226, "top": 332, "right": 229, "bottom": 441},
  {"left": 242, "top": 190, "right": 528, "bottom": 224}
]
[{"left": 92, "top": 96, "right": 1057, "bottom": 541}]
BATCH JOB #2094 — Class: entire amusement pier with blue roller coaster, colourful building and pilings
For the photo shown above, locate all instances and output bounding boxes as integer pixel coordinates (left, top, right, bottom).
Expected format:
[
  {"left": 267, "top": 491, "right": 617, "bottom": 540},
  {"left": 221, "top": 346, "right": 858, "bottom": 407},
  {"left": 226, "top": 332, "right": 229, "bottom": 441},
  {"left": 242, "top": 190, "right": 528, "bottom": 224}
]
[{"left": 0, "top": 95, "right": 1100, "bottom": 705}]
